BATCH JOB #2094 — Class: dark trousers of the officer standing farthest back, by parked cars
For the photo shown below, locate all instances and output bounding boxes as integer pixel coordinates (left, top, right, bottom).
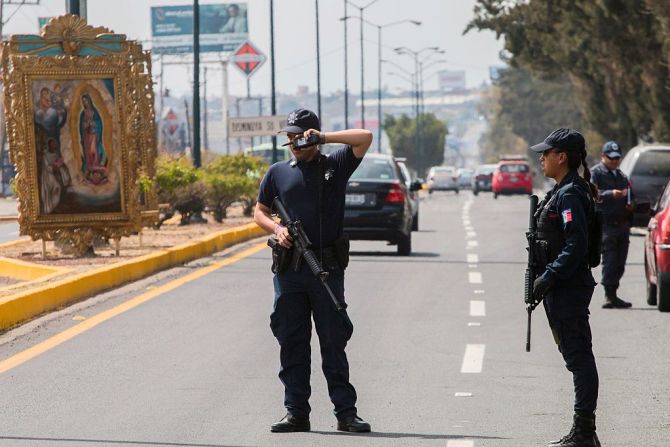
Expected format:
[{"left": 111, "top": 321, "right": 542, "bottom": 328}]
[{"left": 600, "top": 223, "right": 630, "bottom": 291}]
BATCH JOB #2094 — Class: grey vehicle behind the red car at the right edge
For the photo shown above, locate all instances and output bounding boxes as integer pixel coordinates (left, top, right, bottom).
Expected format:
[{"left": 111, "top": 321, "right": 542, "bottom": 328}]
[{"left": 620, "top": 144, "right": 670, "bottom": 227}]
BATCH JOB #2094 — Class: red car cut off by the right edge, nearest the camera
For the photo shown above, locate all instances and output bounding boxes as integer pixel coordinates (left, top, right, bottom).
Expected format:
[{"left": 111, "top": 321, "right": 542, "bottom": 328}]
[{"left": 644, "top": 178, "right": 670, "bottom": 312}]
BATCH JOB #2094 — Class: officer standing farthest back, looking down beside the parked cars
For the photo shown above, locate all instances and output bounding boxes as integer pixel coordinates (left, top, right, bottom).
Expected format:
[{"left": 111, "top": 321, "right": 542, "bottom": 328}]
[{"left": 591, "top": 141, "right": 634, "bottom": 309}]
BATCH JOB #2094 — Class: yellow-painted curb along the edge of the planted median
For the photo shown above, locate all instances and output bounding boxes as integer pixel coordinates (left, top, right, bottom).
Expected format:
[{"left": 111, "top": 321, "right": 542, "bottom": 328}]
[{"left": 0, "top": 223, "right": 266, "bottom": 331}]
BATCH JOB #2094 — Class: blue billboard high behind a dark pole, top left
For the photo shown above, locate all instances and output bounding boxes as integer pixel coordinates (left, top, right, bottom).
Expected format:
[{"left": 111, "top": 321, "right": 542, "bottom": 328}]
[{"left": 151, "top": 3, "right": 249, "bottom": 54}]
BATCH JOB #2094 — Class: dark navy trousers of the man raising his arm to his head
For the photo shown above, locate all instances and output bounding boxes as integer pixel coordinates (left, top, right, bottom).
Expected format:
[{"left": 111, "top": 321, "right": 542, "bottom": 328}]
[{"left": 270, "top": 263, "right": 356, "bottom": 420}]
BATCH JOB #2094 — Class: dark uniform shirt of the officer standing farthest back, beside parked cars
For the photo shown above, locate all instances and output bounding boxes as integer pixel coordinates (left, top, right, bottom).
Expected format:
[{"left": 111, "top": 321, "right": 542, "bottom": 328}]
[{"left": 591, "top": 163, "right": 633, "bottom": 224}]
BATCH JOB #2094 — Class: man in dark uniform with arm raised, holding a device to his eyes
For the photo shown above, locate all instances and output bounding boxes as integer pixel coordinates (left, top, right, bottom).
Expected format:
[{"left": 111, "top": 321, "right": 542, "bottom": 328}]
[{"left": 254, "top": 109, "right": 372, "bottom": 432}]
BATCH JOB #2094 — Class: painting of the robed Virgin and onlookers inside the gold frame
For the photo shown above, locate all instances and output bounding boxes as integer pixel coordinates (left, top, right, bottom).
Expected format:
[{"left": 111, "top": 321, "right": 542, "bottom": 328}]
[{"left": 31, "top": 79, "right": 121, "bottom": 215}]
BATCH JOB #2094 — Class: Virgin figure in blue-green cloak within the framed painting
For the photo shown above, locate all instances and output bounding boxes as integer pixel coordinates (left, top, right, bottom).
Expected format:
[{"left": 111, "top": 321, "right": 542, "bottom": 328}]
[{"left": 79, "top": 94, "right": 108, "bottom": 185}]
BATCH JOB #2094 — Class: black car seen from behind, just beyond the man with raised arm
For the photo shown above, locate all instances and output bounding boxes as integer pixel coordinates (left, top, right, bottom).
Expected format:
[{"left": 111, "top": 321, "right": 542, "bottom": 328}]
[{"left": 344, "top": 154, "right": 421, "bottom": 256}]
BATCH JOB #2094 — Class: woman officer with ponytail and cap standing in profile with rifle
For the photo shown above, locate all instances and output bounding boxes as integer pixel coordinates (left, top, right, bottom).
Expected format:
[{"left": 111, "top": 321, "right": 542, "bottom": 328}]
[{"left": 531, "top": 128, "right": 600, "bottom": 447}]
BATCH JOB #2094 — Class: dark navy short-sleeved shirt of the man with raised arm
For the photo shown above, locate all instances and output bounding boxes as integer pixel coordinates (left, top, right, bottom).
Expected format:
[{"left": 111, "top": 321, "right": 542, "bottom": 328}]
[{"left": 258, "top": 146, "right": 362, "bottom": 248}]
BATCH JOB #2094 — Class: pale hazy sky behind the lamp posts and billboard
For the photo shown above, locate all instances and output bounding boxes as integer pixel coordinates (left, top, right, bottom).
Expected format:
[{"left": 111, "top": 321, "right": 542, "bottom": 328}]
[{"left": 3, "top": 0, "right": 502, "bottom": 96}]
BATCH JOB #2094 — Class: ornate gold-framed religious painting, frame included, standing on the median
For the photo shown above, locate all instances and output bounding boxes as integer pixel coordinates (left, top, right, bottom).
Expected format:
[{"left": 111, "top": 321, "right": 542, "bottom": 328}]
[{"left": 0, "top": 15, "right": 158, "bottom": 252}]
